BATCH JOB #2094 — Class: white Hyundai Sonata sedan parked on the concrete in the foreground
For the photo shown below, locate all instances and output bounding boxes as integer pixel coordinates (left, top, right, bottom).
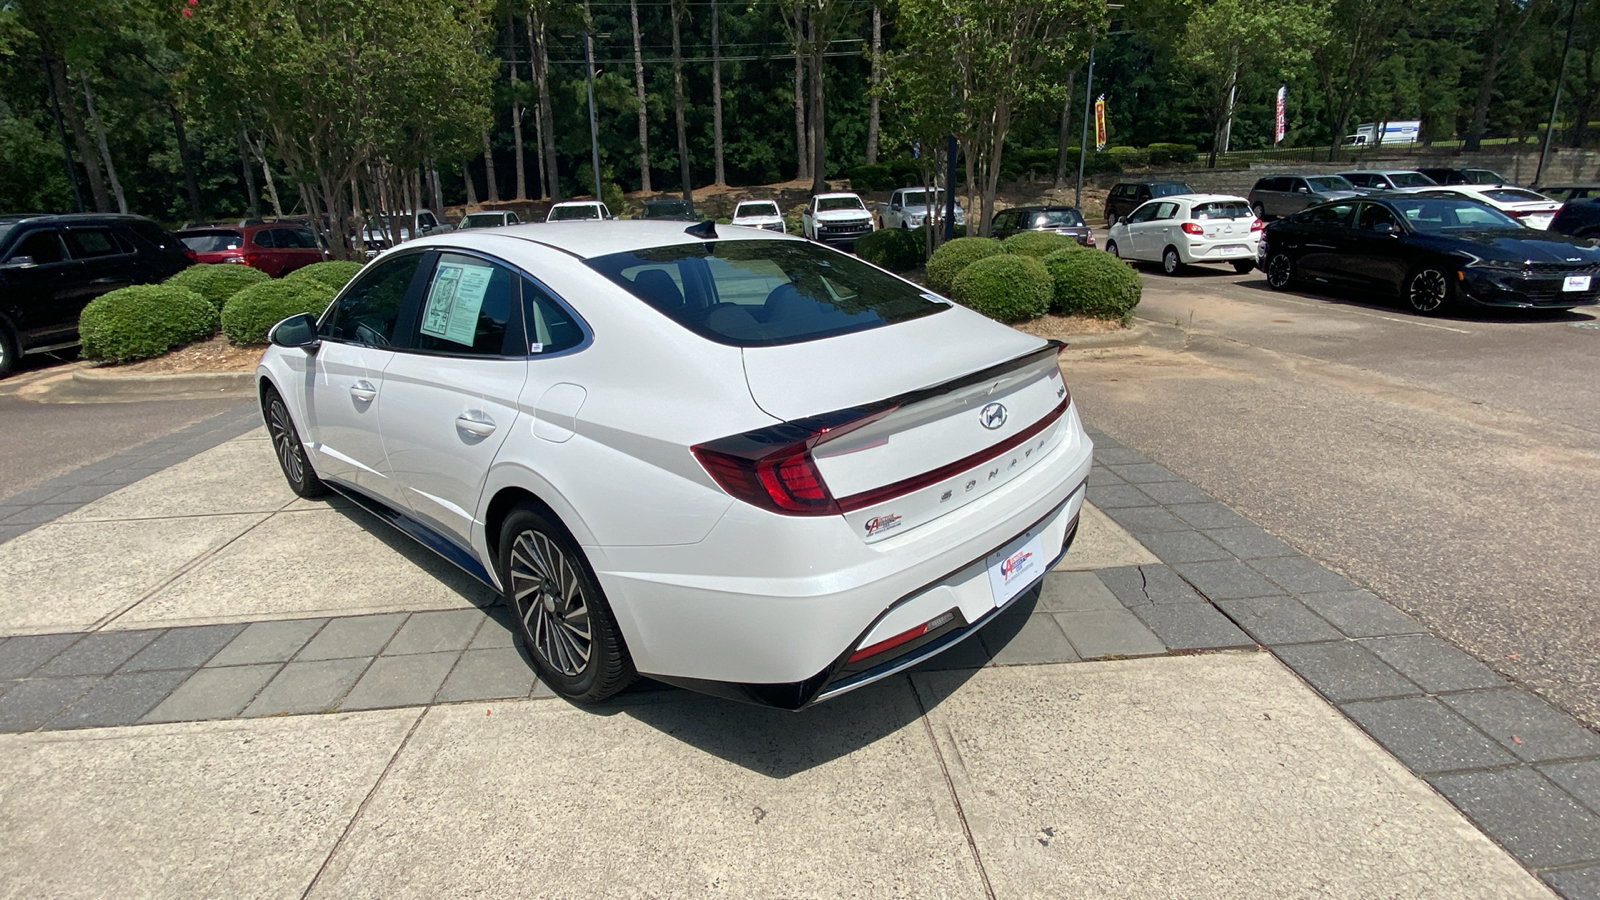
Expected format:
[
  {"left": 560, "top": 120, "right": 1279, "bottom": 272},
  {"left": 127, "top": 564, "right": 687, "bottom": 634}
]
[{"left": 258, "top": 221, "right": 1093, "bottom": 709}]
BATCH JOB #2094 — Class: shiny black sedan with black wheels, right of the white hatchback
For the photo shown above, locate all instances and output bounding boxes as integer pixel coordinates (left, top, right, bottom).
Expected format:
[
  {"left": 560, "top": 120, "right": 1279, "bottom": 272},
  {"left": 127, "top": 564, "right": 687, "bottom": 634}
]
[{"left": 1258, "top": 194, "right": 1600, "bottom": 312}]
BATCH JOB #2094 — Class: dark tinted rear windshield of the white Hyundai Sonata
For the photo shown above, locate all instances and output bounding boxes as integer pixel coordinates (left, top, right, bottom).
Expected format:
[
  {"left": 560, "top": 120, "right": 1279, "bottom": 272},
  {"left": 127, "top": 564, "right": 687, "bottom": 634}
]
[{"left": 589, "top": 240, "right": 949, "bottom": 348}]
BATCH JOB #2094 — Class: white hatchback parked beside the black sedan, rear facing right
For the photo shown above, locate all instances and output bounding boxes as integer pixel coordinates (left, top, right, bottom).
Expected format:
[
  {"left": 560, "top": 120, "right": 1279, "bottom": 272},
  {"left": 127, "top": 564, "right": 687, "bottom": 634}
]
[{"left": 1106, "top": 194, "right": 1262, "bottom": 275}]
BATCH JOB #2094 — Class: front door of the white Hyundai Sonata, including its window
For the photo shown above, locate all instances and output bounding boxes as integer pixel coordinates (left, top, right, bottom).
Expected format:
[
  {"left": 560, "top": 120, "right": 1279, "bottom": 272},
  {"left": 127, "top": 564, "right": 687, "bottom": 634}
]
[{"left": 306, "top": 253, "right": 427, "bottom": 496}]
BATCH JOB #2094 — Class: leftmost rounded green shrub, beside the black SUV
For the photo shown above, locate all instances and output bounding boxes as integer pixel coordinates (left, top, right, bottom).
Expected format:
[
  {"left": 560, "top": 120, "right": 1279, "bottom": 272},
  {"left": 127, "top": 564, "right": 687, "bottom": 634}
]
[{"left": 78, "top": 283, "right": 217, "bottom": 362}]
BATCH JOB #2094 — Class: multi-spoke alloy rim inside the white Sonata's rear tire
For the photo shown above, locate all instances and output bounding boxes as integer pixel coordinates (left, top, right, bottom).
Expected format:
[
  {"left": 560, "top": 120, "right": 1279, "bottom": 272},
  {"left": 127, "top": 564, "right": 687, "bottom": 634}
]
[{"left": 510, "top": 530, "right": 594, "bottom": 677}]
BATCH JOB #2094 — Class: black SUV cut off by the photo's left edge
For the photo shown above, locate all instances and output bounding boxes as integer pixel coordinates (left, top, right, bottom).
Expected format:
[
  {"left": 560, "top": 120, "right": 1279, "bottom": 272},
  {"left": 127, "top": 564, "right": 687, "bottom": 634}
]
[{"left": 0, "top": 215, "right": 194, "bottom": 376}]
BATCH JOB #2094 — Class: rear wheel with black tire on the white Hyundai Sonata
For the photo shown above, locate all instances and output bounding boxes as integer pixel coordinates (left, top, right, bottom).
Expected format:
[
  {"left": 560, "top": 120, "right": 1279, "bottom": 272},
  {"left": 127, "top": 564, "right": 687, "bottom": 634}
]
[{"left": 498, "top": 503, "right": 638, "bottom": 703}]
